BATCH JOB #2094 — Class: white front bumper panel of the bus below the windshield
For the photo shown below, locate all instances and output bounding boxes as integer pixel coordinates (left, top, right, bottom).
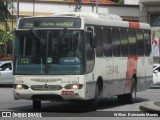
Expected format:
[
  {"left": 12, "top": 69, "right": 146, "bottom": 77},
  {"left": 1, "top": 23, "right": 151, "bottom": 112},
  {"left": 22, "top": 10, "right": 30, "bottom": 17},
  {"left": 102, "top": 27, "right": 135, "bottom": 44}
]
[{"left": 14, "top": 75, "right": 88, "bottom": 100}]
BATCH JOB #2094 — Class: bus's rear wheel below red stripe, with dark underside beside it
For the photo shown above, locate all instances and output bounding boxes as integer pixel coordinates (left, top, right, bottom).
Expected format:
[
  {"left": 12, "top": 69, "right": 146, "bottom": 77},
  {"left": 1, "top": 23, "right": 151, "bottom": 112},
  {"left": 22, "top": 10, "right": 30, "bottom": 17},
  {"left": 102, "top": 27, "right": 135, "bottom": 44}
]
[{"left": 117, "top": 78, "right": 137, "bottom": 104}]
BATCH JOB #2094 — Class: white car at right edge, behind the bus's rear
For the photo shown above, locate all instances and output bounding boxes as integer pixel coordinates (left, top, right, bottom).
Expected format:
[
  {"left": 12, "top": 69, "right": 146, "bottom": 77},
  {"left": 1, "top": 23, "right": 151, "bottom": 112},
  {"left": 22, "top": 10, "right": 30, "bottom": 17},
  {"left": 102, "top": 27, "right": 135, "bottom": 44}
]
[{"left": 153, "top": 64, "right": 160, "bottom": 87}]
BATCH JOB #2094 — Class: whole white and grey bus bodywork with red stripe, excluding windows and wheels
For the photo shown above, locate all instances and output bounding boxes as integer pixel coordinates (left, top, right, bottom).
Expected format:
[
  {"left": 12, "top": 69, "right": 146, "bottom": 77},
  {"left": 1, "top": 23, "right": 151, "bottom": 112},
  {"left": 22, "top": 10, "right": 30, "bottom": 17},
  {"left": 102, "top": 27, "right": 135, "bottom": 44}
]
[{"left": 13, "top": 12, "right": 153, "bottom": 104}]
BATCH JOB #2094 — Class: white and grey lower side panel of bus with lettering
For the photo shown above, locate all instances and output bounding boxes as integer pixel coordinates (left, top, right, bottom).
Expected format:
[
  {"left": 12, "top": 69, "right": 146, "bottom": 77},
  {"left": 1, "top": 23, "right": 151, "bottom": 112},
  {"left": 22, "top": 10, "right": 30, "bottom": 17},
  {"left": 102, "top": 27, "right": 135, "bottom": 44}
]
[{"left": 93, "top": 57, "right": 152, "bottom": 97}]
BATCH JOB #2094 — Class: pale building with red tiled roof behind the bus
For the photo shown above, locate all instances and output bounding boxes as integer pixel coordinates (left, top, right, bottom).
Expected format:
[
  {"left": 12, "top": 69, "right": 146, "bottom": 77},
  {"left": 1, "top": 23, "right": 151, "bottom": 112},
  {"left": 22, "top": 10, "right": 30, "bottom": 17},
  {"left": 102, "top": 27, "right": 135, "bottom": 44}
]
[{"left": 14, "top": 0, "right": 139, "bottom": 21}]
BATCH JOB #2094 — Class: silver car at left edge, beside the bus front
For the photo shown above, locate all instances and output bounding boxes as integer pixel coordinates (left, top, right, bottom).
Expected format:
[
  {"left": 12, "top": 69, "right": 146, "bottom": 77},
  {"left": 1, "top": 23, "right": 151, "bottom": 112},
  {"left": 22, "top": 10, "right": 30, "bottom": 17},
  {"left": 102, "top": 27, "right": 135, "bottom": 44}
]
[{"left": 0, "top": 61, "right": 13, "bottom": 85}]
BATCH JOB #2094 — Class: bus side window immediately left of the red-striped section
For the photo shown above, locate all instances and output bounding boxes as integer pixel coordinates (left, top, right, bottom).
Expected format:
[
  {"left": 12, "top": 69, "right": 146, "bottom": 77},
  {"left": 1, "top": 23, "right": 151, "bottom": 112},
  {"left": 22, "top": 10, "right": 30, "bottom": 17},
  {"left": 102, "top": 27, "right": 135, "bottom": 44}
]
[{"left": 120, "top": 28, "right": 128, "bottom": 56}]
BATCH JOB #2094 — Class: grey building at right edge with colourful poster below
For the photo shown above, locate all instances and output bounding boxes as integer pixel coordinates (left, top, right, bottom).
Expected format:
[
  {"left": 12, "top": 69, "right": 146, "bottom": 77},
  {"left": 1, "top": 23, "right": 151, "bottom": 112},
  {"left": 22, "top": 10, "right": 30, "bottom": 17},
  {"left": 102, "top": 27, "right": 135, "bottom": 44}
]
[{"left": 139, "top": 0, "right": 160, "bottom": 63}]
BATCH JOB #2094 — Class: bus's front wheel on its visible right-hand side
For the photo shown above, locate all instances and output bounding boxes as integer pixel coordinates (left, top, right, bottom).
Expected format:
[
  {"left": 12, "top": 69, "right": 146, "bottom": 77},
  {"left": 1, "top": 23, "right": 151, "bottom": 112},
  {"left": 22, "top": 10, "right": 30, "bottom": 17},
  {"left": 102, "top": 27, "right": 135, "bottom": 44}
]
[{"left": 90, "top": 85, "right": 100, "bottom": 111}]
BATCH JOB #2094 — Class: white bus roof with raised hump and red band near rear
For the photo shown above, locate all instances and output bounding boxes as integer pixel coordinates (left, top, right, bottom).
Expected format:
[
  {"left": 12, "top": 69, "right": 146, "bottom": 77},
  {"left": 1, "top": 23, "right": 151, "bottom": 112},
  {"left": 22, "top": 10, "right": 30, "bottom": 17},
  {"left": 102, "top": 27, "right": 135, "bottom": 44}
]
[{"left": 16, "top": 12, "right": 150, "bottom": 30}]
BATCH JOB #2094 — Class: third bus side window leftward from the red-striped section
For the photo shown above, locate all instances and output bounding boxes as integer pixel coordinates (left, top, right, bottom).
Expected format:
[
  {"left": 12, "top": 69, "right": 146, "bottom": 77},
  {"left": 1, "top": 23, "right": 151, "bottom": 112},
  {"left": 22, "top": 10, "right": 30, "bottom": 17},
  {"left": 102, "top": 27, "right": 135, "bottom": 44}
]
[{"left": 103, "top": 27, "right": 112, "bottom": 57}]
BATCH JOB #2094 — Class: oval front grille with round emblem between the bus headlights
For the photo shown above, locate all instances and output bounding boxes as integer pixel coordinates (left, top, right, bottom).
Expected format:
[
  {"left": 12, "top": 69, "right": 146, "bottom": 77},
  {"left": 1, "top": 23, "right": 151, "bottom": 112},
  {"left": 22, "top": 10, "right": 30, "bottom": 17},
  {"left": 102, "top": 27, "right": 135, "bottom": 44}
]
[{"left": 31, "top": 85, "right": 62, "bottom": 91}]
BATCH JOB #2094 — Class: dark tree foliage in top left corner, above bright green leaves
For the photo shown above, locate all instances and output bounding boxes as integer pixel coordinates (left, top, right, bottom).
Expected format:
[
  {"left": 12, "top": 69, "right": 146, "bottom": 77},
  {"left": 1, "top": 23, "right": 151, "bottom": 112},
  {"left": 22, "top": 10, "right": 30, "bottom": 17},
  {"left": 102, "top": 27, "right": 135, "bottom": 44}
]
[{"left": 0, "top": 0, "right": 12, "bottom": 29}]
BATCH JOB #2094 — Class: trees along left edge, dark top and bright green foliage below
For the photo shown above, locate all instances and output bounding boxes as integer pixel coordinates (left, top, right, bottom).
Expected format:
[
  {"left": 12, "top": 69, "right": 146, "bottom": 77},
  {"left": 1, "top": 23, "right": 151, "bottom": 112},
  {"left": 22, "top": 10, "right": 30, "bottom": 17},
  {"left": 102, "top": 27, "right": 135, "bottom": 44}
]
[{"left": 0, "top": 0, "right": 14, "bottom": 57}]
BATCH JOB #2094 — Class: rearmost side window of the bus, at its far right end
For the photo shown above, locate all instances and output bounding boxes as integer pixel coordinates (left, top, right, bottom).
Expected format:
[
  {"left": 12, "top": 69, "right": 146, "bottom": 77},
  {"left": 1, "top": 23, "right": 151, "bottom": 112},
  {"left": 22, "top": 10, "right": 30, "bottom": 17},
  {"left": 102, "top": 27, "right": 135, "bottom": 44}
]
[{"left": 144, "top": 31, "right": 151, "bottom": 56}]
